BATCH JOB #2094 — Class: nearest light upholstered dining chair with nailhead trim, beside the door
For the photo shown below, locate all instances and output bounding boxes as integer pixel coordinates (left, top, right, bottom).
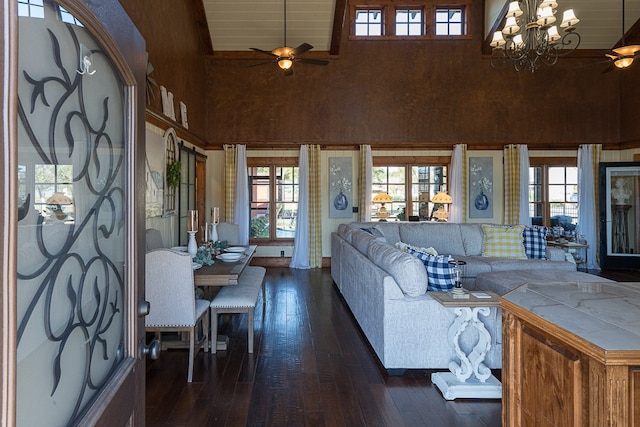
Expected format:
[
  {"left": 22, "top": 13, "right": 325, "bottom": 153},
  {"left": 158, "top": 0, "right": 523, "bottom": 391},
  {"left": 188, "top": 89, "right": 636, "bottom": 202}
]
[{"left": 145, "top": 249, "right": 210, "bottom": 382}]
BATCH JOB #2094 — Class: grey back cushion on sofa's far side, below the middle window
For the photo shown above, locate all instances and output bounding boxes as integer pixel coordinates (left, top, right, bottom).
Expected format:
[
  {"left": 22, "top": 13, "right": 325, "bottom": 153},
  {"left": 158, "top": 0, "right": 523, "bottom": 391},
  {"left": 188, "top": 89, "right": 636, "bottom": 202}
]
[{"left": 399, "top": 222, "right": 465, "bottom": 256}]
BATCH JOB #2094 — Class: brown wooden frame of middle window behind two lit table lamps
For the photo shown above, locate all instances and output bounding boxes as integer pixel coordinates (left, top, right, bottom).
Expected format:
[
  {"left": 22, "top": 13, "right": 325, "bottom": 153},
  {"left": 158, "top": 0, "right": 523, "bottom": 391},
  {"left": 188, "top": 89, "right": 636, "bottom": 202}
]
[{"left": 371, "top": 156, "right": 451, "bottom": 221}]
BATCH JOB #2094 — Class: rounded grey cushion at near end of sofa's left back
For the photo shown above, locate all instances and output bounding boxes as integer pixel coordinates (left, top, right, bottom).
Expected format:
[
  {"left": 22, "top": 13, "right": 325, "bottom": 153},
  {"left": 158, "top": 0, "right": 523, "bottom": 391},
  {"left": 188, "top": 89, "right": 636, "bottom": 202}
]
[{"left": 367, "top": 239, "right": 428, "bottom": 296}]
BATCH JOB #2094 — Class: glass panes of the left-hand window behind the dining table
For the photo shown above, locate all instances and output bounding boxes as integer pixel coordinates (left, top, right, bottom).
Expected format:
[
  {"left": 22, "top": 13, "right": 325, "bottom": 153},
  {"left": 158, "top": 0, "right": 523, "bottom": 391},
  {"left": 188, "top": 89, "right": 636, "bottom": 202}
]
[{"left": 249, "top": 165, "right": 300, "bottom": 240}]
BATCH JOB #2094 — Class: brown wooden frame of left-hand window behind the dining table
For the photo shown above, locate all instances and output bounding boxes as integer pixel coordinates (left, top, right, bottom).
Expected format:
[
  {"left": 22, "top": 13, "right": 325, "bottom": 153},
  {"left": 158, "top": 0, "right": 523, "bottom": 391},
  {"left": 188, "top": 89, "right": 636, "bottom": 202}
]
[{"left": 247, "top": 157, "right": 300, "bottom": 246}]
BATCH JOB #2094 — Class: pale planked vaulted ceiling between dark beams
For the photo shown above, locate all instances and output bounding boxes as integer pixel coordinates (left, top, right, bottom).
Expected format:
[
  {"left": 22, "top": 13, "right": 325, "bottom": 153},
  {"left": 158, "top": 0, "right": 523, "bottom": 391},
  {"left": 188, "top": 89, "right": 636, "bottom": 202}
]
[{"left": 203, "top": 0, "right": 640, "bottom": 52}]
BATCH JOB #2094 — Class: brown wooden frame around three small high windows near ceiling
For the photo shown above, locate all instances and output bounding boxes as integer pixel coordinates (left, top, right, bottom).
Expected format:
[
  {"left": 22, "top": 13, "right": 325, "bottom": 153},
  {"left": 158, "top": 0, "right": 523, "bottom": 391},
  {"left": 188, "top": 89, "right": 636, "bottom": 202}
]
[{"left": 349, "top": 0, "right": 472, "bottom": 40}]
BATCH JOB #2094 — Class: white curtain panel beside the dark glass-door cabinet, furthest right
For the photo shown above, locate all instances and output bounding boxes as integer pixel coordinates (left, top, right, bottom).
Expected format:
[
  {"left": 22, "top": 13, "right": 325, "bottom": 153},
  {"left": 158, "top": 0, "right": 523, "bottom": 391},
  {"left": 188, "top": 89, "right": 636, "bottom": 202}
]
[{"left": 577, "top": 145, "right": 600, "bottom": 269}]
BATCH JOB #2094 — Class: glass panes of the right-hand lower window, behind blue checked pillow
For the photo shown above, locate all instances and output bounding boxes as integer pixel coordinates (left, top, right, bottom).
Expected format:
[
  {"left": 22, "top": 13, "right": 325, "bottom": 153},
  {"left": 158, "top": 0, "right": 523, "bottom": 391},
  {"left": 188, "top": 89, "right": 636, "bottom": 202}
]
[{"left": 529, "top": 163, "right": 578, "bottom": 231}]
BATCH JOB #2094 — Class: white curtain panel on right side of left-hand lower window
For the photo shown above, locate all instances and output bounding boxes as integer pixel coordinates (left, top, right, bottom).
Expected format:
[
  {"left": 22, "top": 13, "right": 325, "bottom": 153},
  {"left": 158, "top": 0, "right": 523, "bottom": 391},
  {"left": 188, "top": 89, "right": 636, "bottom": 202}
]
[{"left": 289, "top": 145, "right": 311, "bottom": 269}]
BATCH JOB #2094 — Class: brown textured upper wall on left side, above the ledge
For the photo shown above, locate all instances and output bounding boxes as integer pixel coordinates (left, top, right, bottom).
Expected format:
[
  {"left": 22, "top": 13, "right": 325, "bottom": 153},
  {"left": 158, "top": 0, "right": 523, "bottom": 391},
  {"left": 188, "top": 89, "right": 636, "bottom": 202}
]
[{"left": 120, "top": 0, "right": 211, "bottom": 138}]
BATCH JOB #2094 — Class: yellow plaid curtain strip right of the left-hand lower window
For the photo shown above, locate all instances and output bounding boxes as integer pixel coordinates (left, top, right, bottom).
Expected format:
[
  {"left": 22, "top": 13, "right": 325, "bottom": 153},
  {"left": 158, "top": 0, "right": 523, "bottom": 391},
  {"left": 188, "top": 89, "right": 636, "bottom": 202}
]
[{"left": 309, "top": 145, "right": 322, "bottom": 268}]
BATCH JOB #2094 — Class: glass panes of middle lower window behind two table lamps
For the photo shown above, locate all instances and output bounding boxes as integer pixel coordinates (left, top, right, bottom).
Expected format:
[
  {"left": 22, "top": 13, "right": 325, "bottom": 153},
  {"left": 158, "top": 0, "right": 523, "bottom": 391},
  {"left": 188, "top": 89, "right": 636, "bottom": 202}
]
[{"left": 371, "top": 158, "right": 447, "bottom": 221}]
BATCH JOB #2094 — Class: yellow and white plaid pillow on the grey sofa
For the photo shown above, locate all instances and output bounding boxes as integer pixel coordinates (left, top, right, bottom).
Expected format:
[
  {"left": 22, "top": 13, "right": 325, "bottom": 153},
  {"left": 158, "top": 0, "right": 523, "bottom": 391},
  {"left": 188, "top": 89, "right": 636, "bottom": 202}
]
[{"left": 482, "top": 224, "right": 527, "bottom": 259}]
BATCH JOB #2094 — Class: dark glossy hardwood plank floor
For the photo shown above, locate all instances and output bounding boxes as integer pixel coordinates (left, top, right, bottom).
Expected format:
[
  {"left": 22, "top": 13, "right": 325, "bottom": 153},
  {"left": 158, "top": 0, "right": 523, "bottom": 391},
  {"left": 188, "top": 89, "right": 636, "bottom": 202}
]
[{"left": 146, "top": 268, "right": 640, "bottom": 427}]
